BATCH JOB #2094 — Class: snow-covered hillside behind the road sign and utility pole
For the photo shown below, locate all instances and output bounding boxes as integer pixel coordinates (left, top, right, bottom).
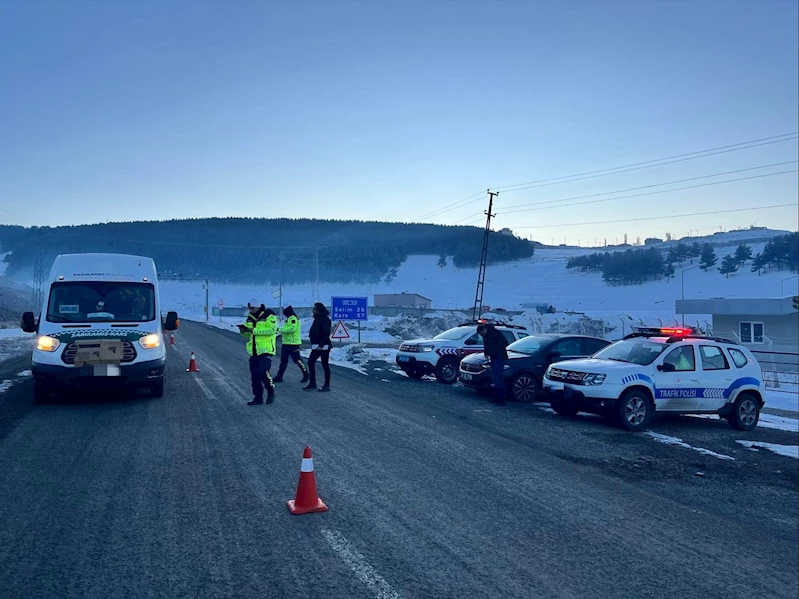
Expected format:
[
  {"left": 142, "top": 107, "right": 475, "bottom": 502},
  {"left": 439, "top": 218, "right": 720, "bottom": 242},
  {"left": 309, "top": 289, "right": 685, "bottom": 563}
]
[{"left": 162, "top": 237, "right": 799, "bottom": 320}]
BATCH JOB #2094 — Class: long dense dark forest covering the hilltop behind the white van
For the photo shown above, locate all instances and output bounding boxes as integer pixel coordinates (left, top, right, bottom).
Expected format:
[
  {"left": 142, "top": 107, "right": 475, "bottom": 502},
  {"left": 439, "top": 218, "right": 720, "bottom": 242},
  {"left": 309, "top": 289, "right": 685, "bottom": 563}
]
[{"left": 0, "top": 218, "right": 535, "bottom": 285}]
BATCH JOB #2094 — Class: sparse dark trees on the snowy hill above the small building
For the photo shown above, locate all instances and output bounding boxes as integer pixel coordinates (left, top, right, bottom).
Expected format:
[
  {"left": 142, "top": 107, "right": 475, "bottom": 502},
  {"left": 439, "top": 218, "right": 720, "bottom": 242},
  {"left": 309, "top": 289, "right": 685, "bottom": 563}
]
[{"left": 566, "top": 233, "right": 799, "bottom": 285}]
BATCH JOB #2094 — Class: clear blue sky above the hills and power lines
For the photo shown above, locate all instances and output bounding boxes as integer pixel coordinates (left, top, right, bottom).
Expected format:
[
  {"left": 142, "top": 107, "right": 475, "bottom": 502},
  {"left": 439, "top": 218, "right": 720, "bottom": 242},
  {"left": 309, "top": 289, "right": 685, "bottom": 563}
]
[{"left": 0, "top": 0, "right": 799, "bottom": 244}]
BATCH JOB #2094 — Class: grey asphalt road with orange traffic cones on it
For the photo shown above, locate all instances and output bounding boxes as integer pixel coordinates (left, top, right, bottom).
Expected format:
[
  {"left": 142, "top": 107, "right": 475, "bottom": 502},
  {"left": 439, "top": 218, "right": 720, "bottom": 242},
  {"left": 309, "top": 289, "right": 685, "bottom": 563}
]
[{"left": 0, "top": 323, "right": 799, "bottom": 599}]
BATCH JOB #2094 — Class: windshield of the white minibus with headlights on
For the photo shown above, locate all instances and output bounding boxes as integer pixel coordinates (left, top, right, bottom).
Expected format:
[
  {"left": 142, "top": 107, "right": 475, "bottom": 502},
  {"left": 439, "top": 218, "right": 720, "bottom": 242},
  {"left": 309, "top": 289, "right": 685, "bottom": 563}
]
[{"left": 47, "top": 281, "right": 155, "bottom": 323}]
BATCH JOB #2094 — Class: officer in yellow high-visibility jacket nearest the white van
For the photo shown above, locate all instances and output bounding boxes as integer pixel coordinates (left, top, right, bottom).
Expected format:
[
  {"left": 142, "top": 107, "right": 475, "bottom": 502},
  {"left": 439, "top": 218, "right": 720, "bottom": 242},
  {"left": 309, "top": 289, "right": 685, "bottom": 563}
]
[{"left": 239, "top": 299, "right": 277, "bottom": 406}]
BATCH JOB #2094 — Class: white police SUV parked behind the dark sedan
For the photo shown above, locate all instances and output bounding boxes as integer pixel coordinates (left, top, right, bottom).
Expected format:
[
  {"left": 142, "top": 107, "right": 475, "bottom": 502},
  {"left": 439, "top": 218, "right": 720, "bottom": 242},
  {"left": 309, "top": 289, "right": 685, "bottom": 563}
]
[{"left": 396, "top": 320, "right": 529, "bottom": 385}]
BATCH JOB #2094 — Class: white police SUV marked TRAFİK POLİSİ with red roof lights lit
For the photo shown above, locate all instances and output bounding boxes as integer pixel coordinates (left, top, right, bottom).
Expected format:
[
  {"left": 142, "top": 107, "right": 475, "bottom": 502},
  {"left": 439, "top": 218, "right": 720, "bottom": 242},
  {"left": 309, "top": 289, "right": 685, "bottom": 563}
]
[{"left": 543, "top": 328, "right": 765, "bottom": 431}]
